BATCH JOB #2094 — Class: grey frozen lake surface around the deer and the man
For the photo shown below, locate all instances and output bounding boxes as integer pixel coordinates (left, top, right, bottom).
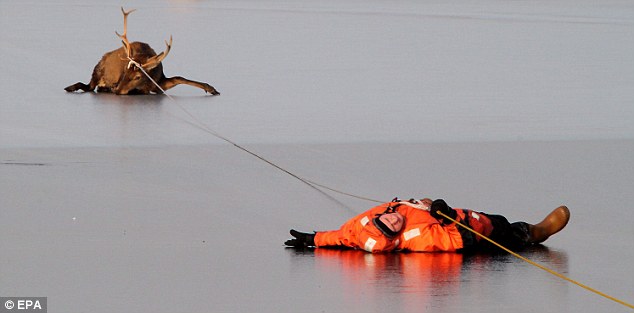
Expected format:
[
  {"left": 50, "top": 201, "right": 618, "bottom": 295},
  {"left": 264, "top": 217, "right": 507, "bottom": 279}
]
[{"left": 0, "top": 0, "right": 634, "bottom": 312}]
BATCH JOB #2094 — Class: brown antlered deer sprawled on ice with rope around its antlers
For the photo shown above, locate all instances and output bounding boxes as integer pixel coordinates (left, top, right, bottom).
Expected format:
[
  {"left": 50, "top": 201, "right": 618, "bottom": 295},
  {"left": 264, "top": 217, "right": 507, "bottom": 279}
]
[{"left": 64, "top": 7, "right": 220, "bottom": 95}]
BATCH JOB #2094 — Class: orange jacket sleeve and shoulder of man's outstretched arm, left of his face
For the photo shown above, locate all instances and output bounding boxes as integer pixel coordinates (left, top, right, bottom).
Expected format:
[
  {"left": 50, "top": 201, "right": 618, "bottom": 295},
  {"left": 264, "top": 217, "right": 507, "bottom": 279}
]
[{"left": 315, "top": 202, "right": 403, "bottom": 253}]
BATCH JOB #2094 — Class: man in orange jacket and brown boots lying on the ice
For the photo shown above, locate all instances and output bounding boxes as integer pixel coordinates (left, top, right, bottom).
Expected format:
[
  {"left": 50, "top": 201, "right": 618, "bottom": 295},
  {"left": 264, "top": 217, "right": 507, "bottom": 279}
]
[{"left": 285, "top": 198, "right": 570, "bottom": 253}]
